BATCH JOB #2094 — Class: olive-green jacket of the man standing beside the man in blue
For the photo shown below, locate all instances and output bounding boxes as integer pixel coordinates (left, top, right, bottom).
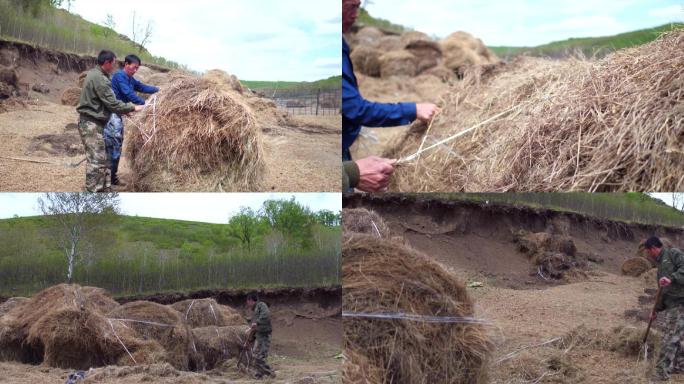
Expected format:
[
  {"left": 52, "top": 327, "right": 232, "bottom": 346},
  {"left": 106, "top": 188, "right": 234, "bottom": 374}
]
[{"left": 76, "top": 67, "right": 135, "bottom": 124}]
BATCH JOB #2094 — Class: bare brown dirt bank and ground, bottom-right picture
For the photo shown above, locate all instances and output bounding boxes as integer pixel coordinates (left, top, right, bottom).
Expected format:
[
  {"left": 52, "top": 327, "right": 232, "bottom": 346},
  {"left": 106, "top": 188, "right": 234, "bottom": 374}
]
[{"left": 344, "top": 198, "right": 684, "bottom": 384}]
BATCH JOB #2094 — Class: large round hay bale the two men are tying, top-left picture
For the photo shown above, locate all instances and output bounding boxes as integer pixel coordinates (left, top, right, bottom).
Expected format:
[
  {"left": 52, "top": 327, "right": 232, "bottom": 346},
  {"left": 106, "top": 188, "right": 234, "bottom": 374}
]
[{"left": 128, "top": 75, "right": 265, "bottom": 191}]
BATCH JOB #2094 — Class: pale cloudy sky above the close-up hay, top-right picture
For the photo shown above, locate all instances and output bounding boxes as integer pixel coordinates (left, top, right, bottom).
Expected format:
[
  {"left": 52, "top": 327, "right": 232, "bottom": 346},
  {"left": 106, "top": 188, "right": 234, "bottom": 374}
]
[{"left": 366, "top": 0, "right": 684, "bottom": 46}]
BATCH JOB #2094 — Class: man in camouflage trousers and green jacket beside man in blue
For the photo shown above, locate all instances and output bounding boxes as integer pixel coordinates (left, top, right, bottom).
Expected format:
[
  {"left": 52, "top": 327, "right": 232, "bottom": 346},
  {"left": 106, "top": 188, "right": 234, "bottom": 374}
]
[{"left": 76, "top": 51, "right": 143, "bottom": 192}]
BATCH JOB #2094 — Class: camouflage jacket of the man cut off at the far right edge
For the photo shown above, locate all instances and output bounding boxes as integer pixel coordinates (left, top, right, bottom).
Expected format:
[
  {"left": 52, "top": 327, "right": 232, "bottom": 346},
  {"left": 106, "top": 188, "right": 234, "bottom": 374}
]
[{"left": 656, "top": 248, "right": 684, "bottom": 310}]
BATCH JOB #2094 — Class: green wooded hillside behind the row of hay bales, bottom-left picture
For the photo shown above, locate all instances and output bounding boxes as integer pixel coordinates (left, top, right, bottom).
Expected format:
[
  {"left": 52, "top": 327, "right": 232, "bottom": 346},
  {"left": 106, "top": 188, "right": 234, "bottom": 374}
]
[{"left": 0, "top": 216, "right": 341, "bottom": 296}]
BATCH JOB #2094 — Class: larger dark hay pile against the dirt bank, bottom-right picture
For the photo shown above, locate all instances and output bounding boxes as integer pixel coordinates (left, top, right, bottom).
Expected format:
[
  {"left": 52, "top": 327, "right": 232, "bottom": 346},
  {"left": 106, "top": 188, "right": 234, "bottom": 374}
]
[{"left": 515, "top": 231, "right": 587, "bottom": 279}]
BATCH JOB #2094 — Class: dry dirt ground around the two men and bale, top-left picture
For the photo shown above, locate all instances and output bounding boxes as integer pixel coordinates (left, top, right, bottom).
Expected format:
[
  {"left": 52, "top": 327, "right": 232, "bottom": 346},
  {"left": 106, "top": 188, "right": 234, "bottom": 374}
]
[{"left": 0, "top": 100, "right": 342, "bottom": 192}]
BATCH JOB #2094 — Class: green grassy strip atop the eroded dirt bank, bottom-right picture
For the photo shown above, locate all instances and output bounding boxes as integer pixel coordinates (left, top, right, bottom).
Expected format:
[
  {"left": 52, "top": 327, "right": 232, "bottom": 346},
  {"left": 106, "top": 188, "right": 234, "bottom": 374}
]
[{"left": 412, "top": 192, "right": 684, "bottom": 227}]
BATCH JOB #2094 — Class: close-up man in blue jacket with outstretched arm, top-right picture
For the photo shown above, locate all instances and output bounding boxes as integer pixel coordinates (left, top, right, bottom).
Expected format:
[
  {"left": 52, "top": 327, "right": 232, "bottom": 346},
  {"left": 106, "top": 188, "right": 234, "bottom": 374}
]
[{"left": 342, "top": 0, "right": 437, "bottom": 161}]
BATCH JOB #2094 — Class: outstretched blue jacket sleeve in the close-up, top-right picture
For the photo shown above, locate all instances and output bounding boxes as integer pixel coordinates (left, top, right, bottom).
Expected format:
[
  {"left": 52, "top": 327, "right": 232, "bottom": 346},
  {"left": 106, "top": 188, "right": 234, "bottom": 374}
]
[{"left": 342, "top": 70, "right": 416, "bottom": 127}]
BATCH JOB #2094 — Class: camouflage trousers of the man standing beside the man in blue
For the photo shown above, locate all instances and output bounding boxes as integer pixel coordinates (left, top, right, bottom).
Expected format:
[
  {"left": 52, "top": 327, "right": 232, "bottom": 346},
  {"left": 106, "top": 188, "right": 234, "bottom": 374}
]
[{"left": 78, "top": 118, "right": 111, "bottom": 192}]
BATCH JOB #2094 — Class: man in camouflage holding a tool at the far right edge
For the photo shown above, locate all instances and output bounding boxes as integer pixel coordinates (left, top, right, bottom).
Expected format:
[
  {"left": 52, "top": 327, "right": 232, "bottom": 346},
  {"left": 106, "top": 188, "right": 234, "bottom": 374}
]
[{"left": 644, "top": 236, "right": 684, "bottom": 381}]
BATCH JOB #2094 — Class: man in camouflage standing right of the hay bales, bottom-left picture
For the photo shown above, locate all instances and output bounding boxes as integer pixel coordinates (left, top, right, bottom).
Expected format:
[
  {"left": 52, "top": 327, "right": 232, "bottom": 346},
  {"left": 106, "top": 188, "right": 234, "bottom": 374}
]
[{"left": 247, "top": 292, "right": 275, "bottom": 379}]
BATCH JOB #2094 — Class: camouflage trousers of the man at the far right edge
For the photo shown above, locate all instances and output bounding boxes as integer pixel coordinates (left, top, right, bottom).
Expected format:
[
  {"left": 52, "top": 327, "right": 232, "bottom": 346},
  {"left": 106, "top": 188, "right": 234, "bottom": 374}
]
[{"left": 655, "top": 305, "right": 684, "bottom": 380}]
